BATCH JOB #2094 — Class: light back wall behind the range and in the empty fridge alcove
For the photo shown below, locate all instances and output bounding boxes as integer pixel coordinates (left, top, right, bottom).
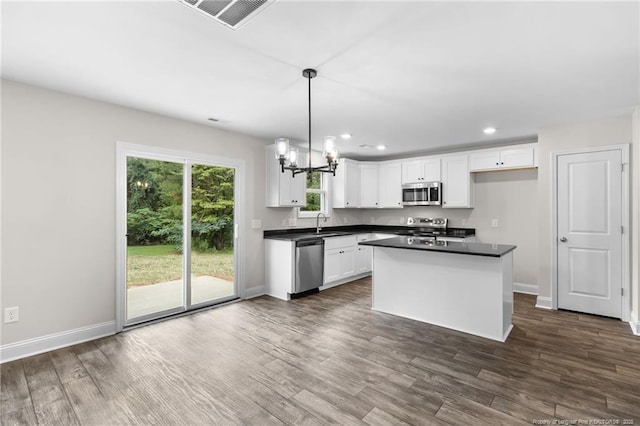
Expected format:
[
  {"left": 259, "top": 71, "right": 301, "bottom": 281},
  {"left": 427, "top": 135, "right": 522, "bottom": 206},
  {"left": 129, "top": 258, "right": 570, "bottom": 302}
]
[{"left": 362, "top": 169, "right": 538, "bottom": 291}]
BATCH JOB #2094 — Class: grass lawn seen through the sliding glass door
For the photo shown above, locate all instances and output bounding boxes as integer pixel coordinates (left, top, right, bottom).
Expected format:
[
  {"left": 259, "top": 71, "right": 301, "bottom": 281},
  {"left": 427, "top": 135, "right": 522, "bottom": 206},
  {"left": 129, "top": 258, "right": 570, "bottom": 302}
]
[{"left": 127, "top": 245, "right": 233, "bottom": 287}]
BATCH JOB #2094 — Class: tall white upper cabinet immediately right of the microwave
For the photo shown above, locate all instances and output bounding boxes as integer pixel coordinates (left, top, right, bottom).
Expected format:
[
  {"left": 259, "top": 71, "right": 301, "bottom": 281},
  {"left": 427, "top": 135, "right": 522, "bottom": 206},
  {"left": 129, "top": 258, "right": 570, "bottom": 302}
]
[{"left": 442, "top": 154, "right": 473, "bottom": 208}]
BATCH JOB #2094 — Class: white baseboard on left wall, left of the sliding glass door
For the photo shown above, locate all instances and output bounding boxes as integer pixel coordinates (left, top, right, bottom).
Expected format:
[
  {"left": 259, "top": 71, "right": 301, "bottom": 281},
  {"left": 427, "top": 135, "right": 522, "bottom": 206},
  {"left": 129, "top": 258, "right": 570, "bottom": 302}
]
[{"left": 0, "top": 321, "right": 116, "bottom": 364}]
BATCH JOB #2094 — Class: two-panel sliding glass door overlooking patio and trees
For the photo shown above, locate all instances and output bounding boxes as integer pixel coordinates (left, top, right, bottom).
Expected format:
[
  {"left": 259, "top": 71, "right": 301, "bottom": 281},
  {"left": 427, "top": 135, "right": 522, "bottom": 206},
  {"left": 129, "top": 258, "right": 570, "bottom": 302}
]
[{"left": 124, "top": 155, "right": 237, "bottom": 326}]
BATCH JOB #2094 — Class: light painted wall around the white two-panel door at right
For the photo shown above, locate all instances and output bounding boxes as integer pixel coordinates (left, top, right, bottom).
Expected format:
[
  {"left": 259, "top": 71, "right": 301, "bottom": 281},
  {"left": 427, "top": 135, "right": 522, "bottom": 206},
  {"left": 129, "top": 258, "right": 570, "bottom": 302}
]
[{"left": 537, "top": 115, "right": 639, "bottom": 314}]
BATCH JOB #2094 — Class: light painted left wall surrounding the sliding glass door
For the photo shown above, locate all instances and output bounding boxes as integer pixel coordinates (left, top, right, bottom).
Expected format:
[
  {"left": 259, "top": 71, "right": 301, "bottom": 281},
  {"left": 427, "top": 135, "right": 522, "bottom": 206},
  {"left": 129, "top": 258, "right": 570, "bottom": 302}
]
[{"left": 0, "top": 80, "right": 360, "bottom": 345}]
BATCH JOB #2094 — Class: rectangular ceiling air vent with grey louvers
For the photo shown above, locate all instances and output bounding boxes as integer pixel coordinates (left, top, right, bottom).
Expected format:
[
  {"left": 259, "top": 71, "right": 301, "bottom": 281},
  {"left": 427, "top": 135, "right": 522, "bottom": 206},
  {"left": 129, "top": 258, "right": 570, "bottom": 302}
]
[{"left": 178, "top": 0, "right": 275, "bottom": 30}]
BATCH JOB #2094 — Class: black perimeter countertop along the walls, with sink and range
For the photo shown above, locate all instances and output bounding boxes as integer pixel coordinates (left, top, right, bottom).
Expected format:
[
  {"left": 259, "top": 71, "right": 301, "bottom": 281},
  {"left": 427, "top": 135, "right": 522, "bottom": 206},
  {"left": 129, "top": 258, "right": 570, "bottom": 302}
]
[{"left": 264, "top": 225, "right": 476, "bottom": 241}]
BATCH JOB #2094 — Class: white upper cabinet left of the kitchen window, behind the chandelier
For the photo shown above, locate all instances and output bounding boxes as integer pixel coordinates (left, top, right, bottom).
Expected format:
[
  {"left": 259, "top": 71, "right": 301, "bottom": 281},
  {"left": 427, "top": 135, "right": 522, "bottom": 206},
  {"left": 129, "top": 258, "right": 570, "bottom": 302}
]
[{"left": 265, "top": 145, "right": 307, "bottom": 207}]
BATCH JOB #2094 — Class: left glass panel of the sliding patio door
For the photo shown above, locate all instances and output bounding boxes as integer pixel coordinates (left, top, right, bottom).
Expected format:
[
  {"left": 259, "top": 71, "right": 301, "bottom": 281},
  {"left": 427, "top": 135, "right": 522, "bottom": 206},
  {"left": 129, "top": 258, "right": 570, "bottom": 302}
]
[{"left": 127, "top": 157, "right": 184, "bottom": 321}]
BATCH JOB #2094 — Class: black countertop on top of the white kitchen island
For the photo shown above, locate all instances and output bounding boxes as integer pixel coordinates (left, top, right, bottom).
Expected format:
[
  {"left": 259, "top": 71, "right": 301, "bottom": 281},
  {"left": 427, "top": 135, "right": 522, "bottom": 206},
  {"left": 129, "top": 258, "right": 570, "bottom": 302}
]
[{"left": 358, "top": 237, "right": 516, "bottom": 257}]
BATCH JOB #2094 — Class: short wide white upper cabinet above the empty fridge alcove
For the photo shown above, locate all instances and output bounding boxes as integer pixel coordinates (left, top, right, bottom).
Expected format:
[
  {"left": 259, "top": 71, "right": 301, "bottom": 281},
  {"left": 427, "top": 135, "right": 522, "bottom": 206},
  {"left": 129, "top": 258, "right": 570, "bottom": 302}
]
[{"left": 469, "top": 144, "right": 538, "bottom": 172}]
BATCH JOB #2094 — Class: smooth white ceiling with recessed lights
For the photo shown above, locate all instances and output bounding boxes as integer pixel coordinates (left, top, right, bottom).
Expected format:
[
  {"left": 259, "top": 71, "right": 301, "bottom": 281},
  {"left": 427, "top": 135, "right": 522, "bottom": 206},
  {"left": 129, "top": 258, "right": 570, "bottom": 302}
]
[{"left": 2, "top": 0, "right": 640, "bottom": 159}]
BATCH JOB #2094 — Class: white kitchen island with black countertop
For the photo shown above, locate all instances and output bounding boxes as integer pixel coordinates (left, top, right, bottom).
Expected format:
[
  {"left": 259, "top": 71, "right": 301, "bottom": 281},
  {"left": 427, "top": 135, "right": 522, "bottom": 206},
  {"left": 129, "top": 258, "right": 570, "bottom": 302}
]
[{"left": 360, "top": 237, "right": 516, "bottom": 342}]
